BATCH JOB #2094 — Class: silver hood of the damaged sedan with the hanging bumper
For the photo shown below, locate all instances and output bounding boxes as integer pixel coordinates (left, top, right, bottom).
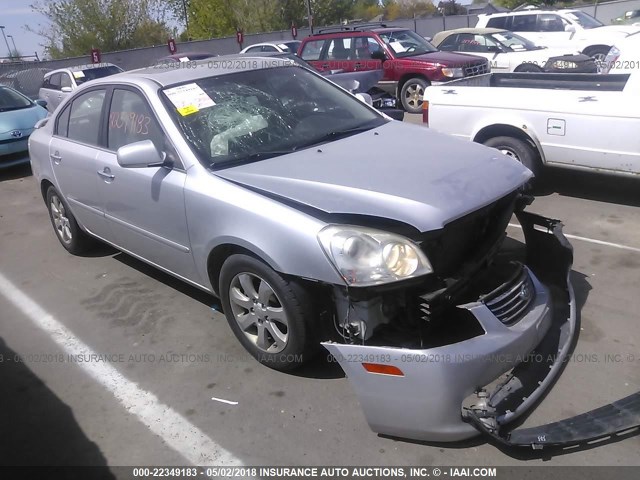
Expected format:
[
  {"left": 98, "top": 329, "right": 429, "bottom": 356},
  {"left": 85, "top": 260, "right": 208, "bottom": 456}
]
[{"left": 215, "top": 122, "right": 531, "bottom": 232}]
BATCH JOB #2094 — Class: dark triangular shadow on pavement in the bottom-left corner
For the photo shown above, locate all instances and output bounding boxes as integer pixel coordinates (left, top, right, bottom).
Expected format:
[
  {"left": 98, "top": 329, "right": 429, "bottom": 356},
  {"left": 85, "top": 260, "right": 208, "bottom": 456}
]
[{"left": 0, "top": 337, "right": 115, "bottom": 480}]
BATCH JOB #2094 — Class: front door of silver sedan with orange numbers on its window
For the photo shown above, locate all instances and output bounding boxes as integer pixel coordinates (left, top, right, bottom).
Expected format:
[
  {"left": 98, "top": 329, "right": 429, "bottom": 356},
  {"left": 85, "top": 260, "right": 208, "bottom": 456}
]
[{"left": 97, "top": 87, "right": 195, "bottom": 278}]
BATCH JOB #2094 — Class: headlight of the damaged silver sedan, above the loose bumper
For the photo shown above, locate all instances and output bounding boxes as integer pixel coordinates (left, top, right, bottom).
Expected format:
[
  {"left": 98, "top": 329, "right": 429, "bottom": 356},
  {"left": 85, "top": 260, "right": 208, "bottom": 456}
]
[{"left": 318, "top": 225, "right": 433, "bottom": 287}]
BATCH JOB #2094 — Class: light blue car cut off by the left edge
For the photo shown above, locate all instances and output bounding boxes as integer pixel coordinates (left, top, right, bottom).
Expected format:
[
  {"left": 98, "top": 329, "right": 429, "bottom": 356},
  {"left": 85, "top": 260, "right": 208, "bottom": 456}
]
[{"left": 0, "top": 85, "right": 47, "bottom": 170}]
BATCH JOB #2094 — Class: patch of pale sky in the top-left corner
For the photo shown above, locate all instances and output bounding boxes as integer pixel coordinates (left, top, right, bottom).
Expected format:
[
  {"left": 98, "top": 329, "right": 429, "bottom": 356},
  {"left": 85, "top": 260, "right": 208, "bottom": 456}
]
[{"left": 0, "top": 0, "right": 47, "bottom": 59}]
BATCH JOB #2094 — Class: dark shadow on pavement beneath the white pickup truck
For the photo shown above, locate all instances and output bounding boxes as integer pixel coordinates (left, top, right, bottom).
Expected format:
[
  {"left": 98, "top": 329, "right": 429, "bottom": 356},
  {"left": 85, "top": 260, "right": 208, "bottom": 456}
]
[{"left": 534, "top": 168, "right": 640, "bottom": 207}]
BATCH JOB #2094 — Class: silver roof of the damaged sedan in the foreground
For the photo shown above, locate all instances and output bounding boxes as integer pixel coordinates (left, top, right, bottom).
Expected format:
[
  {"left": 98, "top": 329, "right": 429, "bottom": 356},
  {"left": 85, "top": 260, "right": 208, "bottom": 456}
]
[{"left": 84, "top": 54, "right": 301, "bottom": 88}]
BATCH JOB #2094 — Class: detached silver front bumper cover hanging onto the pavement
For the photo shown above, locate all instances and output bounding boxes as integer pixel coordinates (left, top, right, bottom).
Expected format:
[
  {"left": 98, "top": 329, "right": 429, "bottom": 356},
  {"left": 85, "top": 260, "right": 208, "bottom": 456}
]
[{"left": 323, "top": 212, "right": 640, "bottom": 448}]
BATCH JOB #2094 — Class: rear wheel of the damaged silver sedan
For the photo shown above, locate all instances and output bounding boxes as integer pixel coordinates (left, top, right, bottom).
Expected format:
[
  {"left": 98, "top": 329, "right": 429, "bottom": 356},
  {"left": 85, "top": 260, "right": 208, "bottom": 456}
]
[{"left": 46, "top": 186, "right": 94, "bottom": 255}]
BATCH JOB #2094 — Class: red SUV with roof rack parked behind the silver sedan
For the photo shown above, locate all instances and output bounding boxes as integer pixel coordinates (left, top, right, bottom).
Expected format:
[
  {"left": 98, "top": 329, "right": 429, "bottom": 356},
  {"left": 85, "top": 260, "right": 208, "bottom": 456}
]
[{"left": 298, "top": 24, "right": 490, "bottom": 113}]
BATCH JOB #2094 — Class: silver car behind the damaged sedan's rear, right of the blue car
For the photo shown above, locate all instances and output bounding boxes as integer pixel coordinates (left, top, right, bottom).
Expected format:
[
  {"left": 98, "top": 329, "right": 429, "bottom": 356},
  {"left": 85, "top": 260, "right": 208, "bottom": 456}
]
[{"left": 38, "top": 63, "right": 122, "bottom": 112}]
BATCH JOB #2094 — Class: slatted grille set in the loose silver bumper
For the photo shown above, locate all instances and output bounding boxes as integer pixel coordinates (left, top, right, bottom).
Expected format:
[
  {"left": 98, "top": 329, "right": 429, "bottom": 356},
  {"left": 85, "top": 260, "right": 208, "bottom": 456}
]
[{"left": 480, "top": 266, "right": 536, "bottom": 325}]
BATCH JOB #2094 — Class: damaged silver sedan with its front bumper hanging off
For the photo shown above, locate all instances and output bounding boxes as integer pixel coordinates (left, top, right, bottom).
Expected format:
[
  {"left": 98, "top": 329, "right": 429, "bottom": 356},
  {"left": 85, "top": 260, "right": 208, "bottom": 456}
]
[{"left": 29, "top": 56, "right": 640, "bottom": 445}]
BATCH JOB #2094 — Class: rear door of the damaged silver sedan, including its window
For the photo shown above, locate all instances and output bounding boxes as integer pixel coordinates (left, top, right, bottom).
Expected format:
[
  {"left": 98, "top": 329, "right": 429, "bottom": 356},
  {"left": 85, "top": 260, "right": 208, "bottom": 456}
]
[{"left": 49, "top": 88, "right": 108, "bottom": 239}]
